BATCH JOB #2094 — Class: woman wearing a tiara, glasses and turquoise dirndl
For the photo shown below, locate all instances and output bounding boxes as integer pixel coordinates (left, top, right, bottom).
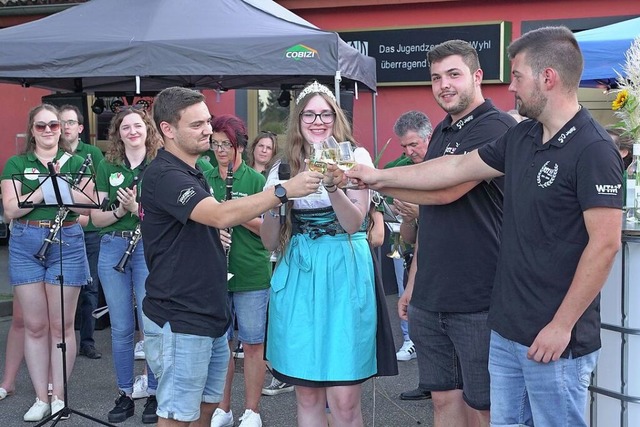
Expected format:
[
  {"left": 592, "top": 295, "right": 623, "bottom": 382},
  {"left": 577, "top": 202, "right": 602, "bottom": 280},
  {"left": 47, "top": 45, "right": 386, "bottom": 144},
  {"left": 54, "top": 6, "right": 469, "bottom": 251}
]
[{"left": 260, "top": 82, "right": 377, "bottom": 426}]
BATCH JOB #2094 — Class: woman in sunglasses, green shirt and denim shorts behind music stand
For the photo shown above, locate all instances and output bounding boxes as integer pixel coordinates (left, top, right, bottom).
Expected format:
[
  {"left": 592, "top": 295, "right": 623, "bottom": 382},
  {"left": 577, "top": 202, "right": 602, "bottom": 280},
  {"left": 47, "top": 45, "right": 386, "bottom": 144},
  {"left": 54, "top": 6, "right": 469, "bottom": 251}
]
[{"left": 1, "top": 104, "right": 93, "bottom": 421}]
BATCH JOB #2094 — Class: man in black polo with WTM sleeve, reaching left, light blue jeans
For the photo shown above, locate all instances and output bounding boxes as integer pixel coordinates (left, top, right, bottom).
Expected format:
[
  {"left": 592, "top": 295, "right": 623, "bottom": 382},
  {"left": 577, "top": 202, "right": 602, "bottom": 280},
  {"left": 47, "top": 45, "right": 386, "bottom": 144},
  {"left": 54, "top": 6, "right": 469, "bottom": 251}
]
[{"left": 348, "top": 27, "right": 622, "bottom": 426}]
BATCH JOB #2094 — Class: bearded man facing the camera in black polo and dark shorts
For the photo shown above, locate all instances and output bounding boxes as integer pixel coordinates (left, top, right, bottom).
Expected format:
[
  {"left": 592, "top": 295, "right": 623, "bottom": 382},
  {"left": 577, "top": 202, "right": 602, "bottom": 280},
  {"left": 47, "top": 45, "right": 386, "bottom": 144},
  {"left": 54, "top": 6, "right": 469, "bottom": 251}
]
[{"left": 398, "top": 40, "right": 515, "bottom": 426}]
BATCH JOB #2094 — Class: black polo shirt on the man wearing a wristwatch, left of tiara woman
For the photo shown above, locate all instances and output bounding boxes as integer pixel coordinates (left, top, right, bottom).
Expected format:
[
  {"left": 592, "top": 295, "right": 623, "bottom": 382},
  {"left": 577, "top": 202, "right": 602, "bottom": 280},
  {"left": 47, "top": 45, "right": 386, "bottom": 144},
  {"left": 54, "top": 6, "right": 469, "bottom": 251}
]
[{"left": 140, "top": 149, "right": 230, "bottom": 337}]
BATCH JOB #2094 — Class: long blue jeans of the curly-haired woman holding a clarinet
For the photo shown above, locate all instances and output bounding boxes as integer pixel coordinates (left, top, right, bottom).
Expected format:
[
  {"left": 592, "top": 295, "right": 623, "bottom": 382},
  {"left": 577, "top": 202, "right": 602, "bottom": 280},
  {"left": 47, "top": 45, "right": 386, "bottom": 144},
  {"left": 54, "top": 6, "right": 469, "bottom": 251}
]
[{"left": 98, "top": 234, "right": 158, "bottom": 394}]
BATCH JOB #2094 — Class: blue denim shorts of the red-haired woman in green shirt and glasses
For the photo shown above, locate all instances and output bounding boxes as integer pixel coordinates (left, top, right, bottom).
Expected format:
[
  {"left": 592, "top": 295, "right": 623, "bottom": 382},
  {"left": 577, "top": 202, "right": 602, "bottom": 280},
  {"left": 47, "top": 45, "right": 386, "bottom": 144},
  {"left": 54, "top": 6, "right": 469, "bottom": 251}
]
[{"left": 227, "top": 289, "right": 269, "bottom": 344}]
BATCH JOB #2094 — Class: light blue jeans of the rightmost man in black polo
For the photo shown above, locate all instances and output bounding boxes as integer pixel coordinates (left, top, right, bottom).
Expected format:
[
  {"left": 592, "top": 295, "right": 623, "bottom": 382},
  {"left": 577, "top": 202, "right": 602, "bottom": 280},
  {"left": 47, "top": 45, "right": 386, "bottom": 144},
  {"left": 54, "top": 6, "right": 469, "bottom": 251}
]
[{"left": 489, "top": 331, "right": 600, "bottom": 427}]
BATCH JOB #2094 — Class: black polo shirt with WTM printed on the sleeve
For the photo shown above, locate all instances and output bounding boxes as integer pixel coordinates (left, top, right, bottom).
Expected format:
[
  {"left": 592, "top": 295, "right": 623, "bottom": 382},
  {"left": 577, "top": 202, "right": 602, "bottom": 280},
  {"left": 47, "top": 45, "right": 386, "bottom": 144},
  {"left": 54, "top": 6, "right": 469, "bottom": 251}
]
[{"left": 479, "top": 108, "right": 623, "bottom": 357}]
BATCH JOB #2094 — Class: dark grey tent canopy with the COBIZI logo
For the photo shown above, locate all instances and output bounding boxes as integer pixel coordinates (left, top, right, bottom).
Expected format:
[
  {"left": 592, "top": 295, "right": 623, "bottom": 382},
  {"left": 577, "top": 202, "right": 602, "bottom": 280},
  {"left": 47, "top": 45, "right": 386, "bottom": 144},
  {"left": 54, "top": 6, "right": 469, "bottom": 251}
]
[{"left": 0, "top": 0, "right": 376, "bottom": 94}]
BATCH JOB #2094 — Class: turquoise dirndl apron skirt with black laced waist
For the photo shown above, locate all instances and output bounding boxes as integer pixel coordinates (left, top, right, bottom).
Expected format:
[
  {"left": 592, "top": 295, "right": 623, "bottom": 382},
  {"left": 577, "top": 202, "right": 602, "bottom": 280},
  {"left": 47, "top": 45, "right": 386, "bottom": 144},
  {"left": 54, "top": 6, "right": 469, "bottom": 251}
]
[{"left": 266, "top": 206, "right": 377, "bottom": 387}]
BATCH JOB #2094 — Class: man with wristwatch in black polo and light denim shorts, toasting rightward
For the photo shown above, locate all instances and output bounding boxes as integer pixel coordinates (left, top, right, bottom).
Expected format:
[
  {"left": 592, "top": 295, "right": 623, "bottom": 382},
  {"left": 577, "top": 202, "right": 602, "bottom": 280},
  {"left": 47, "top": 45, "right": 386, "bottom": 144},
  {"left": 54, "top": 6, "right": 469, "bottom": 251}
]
[{"left": 140, "top": 87, "right": 323, "bottom": 426}]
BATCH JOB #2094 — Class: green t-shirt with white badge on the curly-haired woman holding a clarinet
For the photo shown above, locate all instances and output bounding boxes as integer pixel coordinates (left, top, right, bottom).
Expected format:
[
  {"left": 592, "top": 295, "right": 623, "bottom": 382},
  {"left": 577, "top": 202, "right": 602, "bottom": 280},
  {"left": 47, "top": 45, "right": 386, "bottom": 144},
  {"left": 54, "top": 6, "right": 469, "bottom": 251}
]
[{"left": 96, "top": 160, "right": 145, "bottom": 234}]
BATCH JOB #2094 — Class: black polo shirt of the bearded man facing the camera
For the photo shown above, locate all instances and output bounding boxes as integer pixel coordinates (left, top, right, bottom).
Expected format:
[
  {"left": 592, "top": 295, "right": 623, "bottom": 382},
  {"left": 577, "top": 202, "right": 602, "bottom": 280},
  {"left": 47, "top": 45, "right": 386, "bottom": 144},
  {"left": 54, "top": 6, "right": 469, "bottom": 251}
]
[{"left": 411, "top": 100, "right": 516, "bottom": 313}]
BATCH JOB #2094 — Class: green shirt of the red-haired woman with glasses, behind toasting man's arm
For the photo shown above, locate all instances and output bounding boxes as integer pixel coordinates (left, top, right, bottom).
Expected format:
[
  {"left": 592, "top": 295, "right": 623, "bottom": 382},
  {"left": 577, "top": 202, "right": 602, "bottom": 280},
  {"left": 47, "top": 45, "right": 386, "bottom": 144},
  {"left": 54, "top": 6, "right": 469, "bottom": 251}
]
[{"left": 204, "top": 162, "right": 271, "bottom": 292}]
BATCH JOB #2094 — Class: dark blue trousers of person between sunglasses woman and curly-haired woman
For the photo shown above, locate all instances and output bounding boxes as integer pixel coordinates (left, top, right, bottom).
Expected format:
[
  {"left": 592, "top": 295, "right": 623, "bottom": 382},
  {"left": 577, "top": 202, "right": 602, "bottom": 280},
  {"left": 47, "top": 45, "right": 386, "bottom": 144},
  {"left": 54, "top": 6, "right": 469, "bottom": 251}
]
[{"left": 78, "top": 231, "right": 100, "bottom": 348}]
